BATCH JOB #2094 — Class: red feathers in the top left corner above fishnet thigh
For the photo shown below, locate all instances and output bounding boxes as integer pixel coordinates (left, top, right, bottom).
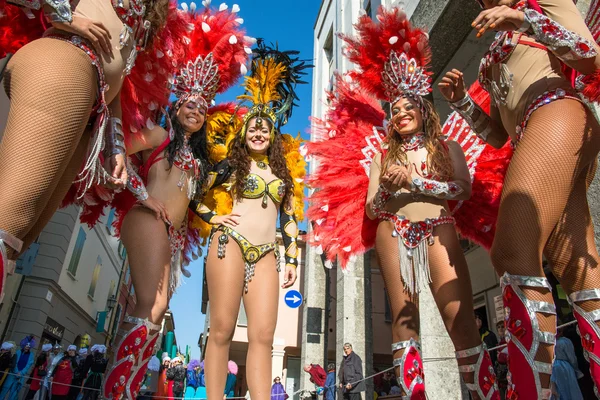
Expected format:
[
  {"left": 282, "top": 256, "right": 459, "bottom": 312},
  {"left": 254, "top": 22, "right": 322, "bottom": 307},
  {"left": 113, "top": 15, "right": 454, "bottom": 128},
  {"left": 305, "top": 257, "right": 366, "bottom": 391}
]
[{"left": 0, "top": 0, "right": 45, "bottom": 58}]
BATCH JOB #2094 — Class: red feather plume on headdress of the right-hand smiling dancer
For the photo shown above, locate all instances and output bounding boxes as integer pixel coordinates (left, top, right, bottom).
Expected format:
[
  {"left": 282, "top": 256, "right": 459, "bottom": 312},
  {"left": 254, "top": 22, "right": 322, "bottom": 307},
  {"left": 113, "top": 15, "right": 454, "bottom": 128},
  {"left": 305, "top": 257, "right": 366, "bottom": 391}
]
[{"left": 340, "top": 6, "right": 431, "bottom": 100}]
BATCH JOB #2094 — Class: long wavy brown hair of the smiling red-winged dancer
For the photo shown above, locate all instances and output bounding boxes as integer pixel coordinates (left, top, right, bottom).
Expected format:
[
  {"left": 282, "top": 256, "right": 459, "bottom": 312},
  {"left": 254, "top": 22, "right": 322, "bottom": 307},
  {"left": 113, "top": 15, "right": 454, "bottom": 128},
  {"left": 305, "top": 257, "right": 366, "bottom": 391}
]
[{"left": 381, "top": 99, "right": 454, "bottom": 181}]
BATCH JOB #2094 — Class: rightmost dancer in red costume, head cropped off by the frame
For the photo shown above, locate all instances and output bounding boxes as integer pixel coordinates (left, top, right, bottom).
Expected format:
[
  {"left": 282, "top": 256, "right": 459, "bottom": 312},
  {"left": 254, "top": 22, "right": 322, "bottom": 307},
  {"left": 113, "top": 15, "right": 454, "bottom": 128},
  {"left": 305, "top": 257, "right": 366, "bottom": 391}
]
[{"left": 440, "top": 0, "right": 600, "bottom": 399}]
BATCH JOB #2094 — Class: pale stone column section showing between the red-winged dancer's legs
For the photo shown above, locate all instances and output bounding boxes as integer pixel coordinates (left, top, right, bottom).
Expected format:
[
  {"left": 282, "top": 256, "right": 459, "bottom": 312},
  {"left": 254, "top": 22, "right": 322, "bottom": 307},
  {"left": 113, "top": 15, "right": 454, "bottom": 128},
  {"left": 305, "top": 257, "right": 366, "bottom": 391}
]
[{"left": 419, "top": 290, "right": 469, "bottom": 400}]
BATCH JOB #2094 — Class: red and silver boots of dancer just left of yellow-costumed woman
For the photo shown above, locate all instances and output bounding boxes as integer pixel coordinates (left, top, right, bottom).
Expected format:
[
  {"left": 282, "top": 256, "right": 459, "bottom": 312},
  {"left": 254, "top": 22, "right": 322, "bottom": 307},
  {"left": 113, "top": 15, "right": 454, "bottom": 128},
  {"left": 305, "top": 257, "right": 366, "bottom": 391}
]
[{"left": 102, "top": 316, "right": 161, "bottom": 400}]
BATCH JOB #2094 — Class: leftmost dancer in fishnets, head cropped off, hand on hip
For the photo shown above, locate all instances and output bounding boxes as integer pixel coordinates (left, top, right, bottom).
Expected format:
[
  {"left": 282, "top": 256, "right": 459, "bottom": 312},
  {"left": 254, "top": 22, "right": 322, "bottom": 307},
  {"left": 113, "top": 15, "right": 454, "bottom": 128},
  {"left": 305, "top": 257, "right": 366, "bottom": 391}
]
[{"left": 0, "top": 0, "right": 186, "bottom": 302}]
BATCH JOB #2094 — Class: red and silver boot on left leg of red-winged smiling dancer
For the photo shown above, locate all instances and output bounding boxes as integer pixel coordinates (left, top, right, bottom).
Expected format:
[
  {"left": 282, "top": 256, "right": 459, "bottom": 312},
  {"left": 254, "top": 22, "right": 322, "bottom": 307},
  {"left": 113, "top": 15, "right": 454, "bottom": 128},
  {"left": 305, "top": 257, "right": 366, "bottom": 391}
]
[{"left": 392, "top": 338, "right": 427, "bottom": 400}]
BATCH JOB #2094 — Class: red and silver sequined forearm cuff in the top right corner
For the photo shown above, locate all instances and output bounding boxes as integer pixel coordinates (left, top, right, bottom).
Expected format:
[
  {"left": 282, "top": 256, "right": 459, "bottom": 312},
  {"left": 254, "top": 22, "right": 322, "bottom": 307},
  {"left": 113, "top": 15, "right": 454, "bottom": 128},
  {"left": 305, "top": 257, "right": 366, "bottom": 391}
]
[{"left": 525, "top": 9, "right": 598, "bottom": 60}]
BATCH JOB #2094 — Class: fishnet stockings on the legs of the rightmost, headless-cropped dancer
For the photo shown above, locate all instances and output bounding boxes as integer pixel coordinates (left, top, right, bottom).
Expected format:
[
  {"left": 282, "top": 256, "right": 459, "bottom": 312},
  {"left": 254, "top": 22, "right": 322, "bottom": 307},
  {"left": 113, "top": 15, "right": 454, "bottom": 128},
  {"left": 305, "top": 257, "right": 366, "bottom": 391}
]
[{"left": 491, "top": 99, "right": 600, "bottom": 388}]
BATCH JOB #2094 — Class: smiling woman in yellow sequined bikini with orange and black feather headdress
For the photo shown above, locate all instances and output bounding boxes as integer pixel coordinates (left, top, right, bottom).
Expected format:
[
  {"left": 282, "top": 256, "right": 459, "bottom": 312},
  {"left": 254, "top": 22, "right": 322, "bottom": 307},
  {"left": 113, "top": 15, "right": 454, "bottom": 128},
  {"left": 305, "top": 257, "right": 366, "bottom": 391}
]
[{"left": 196, "top": 41, "right": 308, "bottom": 400}]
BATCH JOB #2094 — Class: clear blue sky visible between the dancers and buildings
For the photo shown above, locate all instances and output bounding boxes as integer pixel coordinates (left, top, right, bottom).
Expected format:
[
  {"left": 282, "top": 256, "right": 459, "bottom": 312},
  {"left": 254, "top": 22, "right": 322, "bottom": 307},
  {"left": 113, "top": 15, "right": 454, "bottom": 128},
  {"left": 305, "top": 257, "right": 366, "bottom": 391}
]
[{"left": 170, "top": 0, "right": 321, "bottom": 357}]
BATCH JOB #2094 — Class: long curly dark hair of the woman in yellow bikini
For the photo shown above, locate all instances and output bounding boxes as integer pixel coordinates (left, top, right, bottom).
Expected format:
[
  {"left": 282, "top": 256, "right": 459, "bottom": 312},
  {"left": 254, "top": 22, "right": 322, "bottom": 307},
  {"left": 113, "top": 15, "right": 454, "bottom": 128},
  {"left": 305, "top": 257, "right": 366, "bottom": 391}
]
[{"left": 227, "top": 119, "right": 294, "bottom": 204}]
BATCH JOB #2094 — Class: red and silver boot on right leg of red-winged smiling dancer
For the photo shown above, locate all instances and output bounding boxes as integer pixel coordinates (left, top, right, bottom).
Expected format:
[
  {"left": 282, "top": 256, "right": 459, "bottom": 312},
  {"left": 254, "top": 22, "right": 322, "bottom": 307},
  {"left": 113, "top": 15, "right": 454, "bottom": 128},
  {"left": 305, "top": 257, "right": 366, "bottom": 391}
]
[{"left": 456, "top": 343, "right": 500, "bottom": 400}]
